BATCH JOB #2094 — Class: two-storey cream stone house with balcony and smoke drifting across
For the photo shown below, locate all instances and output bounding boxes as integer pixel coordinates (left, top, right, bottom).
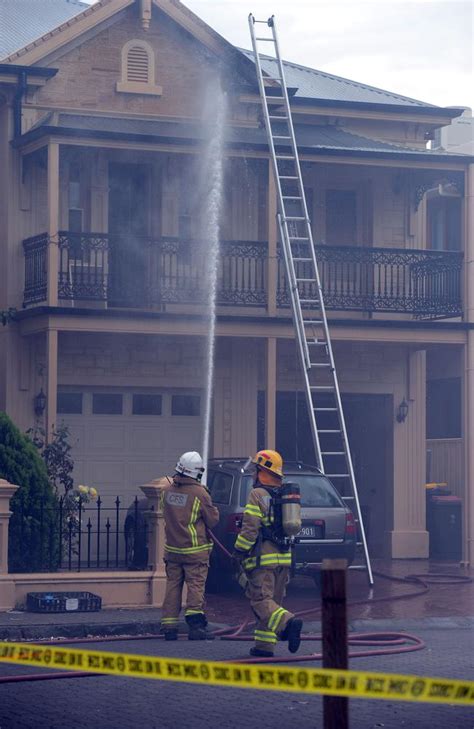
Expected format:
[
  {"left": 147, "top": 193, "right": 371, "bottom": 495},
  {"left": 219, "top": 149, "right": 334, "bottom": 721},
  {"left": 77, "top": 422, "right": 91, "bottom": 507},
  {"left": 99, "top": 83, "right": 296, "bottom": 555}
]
[{"left": 0, "top": 0, "right": 474, "bottom": 561}]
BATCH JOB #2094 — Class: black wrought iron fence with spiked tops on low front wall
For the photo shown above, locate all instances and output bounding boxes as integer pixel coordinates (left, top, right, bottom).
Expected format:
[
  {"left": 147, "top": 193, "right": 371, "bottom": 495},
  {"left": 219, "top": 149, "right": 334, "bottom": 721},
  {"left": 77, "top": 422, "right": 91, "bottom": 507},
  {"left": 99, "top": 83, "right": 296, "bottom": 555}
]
[{"left": 10, "top": 496, "right": 148, "bottom": 572}]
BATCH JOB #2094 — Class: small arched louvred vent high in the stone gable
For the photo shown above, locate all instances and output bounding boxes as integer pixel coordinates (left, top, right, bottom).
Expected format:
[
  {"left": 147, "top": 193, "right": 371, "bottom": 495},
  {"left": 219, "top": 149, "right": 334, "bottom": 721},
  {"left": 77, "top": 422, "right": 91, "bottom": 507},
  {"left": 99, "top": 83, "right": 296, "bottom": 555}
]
[{"left": 117, "top": 40, "right": 162, "bottom": 96}]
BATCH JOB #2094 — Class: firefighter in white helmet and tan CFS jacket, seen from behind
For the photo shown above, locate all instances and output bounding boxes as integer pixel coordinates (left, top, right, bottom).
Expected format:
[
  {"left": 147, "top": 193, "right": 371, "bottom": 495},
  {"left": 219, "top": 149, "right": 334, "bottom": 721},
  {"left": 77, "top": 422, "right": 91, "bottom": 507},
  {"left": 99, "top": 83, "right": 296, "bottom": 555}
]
[{"left": 161, "top": 451, "right": 219, "bottom": 640}]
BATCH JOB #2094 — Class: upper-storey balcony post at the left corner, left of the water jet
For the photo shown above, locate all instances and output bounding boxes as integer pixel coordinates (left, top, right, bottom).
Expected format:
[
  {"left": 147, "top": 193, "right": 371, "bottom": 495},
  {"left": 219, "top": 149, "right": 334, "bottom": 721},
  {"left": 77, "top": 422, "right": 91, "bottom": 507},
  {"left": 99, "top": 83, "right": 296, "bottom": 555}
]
[{"left": 47, "top": 142, "right": 59, "bottom": 306}]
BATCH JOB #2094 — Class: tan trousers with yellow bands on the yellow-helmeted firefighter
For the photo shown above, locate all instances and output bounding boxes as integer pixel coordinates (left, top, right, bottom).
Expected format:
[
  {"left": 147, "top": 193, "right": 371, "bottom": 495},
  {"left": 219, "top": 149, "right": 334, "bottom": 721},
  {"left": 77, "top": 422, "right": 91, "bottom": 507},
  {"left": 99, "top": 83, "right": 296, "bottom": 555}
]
[{"left": 245, "top": 567, "right": 293, "bottom": 653}]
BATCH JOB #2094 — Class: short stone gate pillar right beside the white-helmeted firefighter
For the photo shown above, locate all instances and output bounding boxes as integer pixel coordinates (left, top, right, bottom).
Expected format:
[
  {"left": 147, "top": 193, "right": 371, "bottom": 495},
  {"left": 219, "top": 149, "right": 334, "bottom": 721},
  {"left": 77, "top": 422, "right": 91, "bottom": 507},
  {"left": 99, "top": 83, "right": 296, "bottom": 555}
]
[{"left": 140, "top": 478, "right": 167, "bottom": 607}]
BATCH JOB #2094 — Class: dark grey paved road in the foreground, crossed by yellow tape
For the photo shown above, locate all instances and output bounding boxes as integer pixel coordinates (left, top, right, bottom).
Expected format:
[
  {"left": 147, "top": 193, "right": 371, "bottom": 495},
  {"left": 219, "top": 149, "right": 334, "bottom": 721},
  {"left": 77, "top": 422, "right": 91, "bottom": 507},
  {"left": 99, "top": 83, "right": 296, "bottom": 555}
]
[{"left": 0, "top": 627, "right": 474, "bottom": 729}]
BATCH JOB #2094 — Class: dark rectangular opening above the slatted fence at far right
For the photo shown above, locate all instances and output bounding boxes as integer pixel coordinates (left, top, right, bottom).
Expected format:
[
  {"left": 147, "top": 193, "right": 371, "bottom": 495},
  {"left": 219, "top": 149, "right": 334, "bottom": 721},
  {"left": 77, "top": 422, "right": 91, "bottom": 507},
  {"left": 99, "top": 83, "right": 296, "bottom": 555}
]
[{"left": 426, "top": 377, "right": 462, "bottom": 438}]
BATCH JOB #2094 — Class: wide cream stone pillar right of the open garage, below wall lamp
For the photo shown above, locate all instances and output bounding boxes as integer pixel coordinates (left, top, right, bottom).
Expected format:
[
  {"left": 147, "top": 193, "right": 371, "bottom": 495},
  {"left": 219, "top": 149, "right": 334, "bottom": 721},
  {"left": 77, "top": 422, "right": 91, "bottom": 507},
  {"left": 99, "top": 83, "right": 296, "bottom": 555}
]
[{"left": 390, "top": 350, "right": 429, "bottom": 559}]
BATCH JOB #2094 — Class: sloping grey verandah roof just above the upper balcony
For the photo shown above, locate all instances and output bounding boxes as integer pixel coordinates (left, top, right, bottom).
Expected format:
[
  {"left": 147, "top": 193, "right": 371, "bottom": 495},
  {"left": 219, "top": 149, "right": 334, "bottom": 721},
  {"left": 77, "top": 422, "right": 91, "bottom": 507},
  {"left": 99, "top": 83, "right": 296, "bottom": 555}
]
[{"left": 16, "top": 112, "right": 474, "bottom": 159}]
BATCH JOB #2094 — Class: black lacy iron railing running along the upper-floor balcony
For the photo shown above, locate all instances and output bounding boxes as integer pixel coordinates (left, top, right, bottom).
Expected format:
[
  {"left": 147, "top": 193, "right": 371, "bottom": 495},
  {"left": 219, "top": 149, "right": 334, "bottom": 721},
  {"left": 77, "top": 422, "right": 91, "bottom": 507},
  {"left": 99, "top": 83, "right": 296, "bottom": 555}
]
[{"left": 23, "top": 231, "right": 462, "bottom": 319}]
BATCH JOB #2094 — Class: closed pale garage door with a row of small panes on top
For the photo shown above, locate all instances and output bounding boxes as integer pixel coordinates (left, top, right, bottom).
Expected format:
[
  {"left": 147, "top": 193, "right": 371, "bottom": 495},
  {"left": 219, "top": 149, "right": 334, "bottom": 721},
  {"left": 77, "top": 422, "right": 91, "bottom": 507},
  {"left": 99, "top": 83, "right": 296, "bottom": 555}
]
[{"left": 58, "top": 388, "right": 202, "bottom": 503}]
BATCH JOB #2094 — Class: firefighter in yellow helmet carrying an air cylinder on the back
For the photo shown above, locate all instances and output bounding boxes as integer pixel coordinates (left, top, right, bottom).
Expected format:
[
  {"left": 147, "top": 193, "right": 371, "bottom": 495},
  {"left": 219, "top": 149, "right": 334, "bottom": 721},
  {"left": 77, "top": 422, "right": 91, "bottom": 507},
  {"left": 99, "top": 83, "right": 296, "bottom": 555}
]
[{"left": 235, "top": 450, "right": 303, "bottom": 657}]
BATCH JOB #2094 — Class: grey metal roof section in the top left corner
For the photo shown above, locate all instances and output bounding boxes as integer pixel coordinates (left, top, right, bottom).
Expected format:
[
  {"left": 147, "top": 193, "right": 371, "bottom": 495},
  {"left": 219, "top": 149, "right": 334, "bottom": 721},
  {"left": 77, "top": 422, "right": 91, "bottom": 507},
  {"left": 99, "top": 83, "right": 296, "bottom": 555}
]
[{"left": 0, "top": 0, "right": 90, "bottom": 59}]
